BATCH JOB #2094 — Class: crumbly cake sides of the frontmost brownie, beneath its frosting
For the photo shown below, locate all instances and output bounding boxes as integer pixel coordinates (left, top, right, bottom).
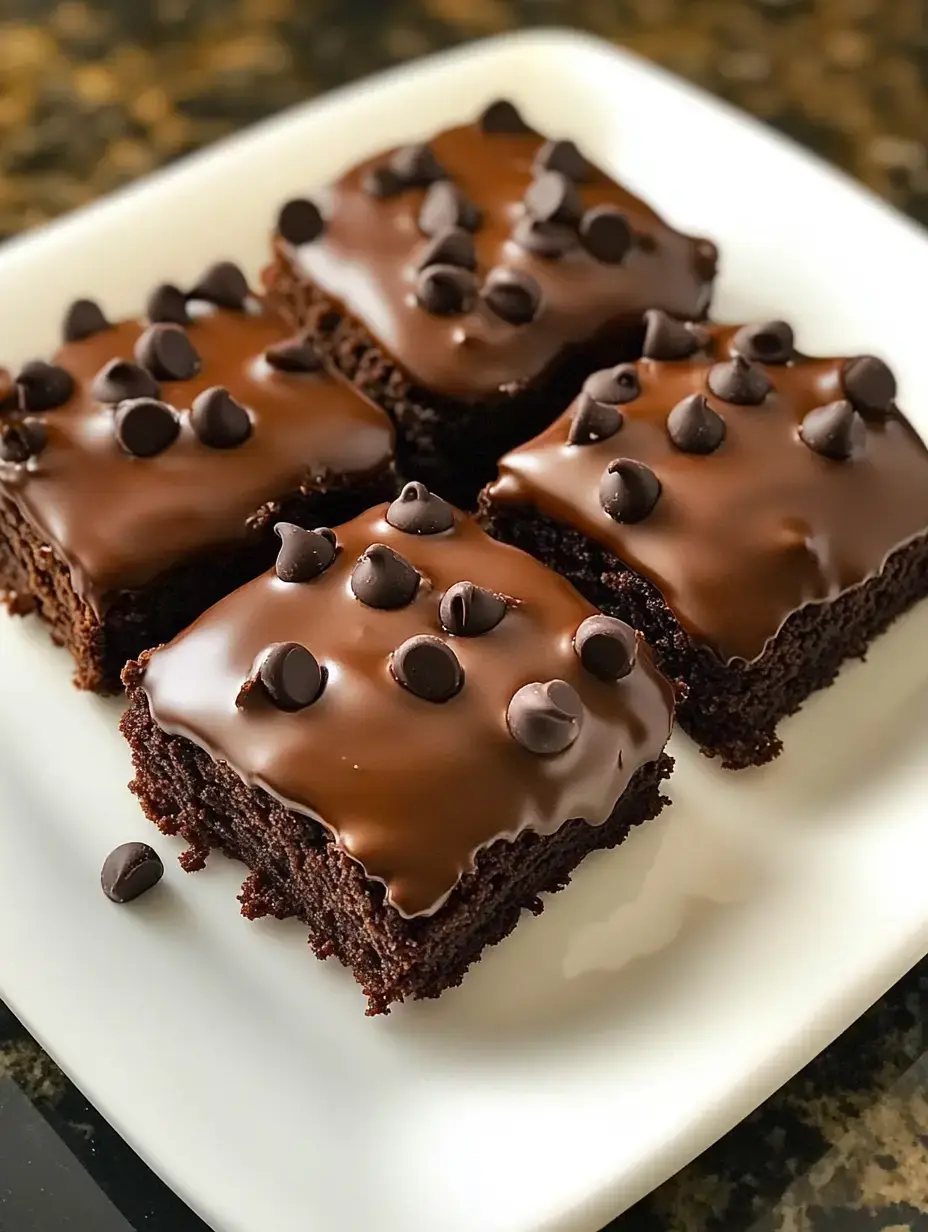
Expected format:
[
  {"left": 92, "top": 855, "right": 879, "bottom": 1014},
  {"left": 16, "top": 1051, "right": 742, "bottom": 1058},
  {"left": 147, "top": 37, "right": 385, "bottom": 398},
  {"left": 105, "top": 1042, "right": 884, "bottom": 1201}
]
[{"left": 121, "top": 680, "right": 673, "bottom": 1014}]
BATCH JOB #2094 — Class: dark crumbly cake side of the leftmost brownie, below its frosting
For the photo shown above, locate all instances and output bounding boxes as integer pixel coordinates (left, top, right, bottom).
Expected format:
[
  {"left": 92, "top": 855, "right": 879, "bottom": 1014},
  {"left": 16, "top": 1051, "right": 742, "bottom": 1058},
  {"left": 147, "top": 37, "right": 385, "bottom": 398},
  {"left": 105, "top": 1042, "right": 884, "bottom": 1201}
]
[{"left": 0, "top": 466, "right": 398, "bottom": 694}]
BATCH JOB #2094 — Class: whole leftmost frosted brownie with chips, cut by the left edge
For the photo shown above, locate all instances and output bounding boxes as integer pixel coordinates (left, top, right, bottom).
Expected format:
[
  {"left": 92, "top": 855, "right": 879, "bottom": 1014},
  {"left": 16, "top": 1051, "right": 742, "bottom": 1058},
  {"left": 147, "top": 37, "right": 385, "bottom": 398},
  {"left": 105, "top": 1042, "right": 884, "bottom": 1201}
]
[{"left": 0, "top": 262, "right": 397, "bottom": 692}]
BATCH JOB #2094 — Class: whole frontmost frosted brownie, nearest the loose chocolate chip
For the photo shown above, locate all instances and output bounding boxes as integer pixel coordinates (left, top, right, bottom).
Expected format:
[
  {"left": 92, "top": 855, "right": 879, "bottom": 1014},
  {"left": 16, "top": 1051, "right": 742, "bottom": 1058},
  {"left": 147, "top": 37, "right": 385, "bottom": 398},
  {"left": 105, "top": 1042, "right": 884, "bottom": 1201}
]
[{"left": 122, "top": 483, "right": 673, "bottom": 1014}]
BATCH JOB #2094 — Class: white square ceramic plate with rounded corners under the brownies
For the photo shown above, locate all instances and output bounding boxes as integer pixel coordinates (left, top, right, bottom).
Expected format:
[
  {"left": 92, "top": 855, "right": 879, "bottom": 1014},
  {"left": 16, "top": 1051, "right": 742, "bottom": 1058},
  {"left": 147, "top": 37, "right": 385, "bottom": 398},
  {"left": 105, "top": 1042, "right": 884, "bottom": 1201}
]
[{"left": 0, "top": 26, "right": 928, "bottom": 1232}]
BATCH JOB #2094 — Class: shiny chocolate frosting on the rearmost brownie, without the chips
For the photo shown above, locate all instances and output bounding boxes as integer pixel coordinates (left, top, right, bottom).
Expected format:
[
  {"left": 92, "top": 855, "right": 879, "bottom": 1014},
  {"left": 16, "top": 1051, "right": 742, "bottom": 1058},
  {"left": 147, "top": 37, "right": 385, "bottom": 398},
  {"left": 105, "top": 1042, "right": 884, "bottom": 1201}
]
[{"left": 276, "top": 112, "right": 715, "bottom": 402}]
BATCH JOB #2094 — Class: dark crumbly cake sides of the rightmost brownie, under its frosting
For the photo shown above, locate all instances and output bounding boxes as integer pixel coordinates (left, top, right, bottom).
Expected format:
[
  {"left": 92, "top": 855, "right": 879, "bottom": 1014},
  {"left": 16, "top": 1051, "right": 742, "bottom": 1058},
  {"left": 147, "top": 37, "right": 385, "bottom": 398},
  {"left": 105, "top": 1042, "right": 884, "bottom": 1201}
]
[{"left": 481, "top": 494, "right": 928, "bottom": 770}]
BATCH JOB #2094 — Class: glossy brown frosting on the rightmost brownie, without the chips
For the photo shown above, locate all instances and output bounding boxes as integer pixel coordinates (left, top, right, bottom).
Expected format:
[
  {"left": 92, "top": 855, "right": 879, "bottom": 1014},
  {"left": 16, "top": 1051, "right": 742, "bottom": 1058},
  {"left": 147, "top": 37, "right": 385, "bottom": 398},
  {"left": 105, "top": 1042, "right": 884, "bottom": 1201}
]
[{"left": 487, "top": 326, "right": 928, "bottom": 662}]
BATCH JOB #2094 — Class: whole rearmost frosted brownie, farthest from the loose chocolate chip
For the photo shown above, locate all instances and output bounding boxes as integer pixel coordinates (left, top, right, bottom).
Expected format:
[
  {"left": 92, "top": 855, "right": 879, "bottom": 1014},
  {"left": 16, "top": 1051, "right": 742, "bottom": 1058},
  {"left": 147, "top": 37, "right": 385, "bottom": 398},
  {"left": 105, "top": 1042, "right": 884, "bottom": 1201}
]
[{"left": 265, "top": 94, "right": 717, "bottom": 508}]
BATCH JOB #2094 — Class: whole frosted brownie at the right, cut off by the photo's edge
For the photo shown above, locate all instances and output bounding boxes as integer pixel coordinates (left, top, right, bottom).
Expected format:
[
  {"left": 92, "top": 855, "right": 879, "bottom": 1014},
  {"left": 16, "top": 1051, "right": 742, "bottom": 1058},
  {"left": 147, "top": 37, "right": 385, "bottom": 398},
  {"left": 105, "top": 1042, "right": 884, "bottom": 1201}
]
[{"left": 482, "top": 313, "right": 928, "bottom": 769}]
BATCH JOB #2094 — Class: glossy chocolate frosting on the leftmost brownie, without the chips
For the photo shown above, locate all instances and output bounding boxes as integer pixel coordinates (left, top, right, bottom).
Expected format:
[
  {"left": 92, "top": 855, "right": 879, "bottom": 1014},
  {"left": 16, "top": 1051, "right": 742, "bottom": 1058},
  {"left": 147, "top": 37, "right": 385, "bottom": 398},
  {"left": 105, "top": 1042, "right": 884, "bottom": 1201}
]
[{"left": 0, "top": 290, "right": 393, "bottom": 614}]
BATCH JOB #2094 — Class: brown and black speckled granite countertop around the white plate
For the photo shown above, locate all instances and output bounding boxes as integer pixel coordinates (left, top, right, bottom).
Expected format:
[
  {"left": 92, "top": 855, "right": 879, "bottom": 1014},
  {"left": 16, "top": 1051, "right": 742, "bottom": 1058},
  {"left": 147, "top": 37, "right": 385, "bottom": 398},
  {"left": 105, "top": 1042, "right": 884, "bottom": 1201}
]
[{"left": 0, "top": 0, "right": 928, "bottom": 1232}]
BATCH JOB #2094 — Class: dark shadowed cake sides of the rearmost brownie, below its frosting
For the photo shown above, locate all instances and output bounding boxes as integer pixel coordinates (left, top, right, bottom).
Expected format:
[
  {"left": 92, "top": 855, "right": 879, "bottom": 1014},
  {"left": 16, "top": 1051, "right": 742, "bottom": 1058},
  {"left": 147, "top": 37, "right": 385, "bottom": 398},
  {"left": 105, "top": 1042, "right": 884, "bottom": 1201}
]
[{"left": 264, "top": 253, "right": 643, "bottom": 509}]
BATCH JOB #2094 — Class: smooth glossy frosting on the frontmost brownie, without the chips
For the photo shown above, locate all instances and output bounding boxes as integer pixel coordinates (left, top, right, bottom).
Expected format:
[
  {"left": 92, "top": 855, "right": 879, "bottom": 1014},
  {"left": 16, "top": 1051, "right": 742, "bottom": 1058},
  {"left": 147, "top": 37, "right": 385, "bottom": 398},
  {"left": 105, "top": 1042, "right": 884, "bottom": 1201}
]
[{"left": 137, "top": 506, "right": 673, "bottom": 915}]
